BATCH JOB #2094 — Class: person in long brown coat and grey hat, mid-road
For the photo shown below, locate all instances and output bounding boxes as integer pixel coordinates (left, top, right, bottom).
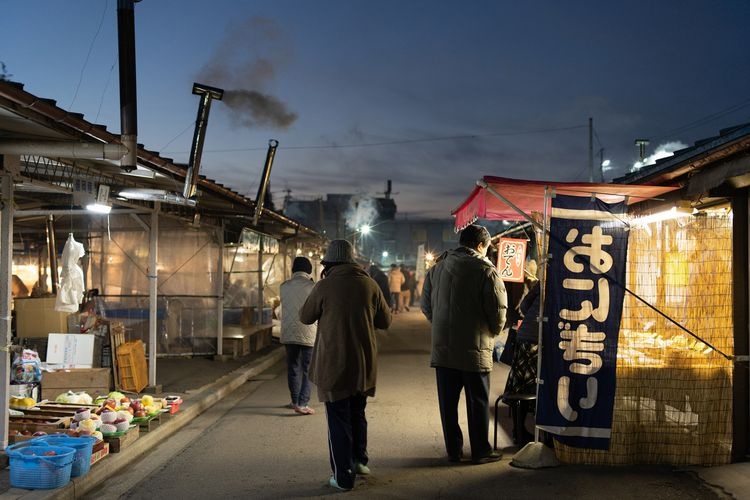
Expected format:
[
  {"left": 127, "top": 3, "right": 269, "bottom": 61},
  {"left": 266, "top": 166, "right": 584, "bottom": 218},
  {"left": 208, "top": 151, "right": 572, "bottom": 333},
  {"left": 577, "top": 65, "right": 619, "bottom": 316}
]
[{"left": 299, "top": 240, "right": 391, "bottom": 490}]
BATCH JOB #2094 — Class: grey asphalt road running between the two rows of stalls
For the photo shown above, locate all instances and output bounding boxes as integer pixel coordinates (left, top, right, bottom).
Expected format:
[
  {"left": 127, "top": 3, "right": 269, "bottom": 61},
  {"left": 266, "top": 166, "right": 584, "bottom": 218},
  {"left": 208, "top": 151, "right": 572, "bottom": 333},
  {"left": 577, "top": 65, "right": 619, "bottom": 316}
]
[{"left": 86, "top": 312, "right": 721, "bottom": 500}]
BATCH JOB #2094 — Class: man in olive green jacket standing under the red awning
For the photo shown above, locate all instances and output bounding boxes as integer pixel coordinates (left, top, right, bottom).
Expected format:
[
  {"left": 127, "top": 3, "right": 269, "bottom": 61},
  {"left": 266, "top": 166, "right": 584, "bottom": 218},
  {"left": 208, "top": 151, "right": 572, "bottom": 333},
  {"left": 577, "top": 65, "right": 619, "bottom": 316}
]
[{"left": 422, "top": 225, "right": 508, "bottom": 464}]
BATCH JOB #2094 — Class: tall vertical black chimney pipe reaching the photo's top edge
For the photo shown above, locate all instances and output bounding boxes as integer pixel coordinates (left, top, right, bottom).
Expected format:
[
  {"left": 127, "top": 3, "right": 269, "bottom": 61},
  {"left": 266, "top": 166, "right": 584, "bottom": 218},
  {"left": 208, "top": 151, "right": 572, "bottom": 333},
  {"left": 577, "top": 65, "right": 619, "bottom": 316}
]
[{"left": 117, "top": 0, "right": 140, "bottom": 172}]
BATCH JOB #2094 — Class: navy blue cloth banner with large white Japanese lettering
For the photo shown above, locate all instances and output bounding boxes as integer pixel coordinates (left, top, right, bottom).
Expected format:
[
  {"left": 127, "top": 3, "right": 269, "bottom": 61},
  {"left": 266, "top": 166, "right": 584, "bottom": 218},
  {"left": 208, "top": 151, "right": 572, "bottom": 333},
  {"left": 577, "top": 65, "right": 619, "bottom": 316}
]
[{"left": 537, "top": 195, "right": 628, "bottom": 449}]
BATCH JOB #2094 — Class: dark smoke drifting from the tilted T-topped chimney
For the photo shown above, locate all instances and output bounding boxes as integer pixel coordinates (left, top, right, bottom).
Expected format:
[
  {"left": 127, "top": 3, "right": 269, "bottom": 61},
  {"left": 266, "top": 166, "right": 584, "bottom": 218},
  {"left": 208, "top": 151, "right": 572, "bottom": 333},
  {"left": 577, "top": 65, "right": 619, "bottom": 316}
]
[{"left": 198, "top": 17, "right": 297, "bottom": 129}]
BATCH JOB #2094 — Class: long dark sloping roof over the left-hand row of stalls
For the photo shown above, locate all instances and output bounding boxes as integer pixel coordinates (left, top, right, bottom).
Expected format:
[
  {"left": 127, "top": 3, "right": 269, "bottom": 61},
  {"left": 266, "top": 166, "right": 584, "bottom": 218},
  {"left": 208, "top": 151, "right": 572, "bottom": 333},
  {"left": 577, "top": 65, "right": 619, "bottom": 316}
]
[{"left": 0, "top": 80, "right": 321, "bottom": 243}]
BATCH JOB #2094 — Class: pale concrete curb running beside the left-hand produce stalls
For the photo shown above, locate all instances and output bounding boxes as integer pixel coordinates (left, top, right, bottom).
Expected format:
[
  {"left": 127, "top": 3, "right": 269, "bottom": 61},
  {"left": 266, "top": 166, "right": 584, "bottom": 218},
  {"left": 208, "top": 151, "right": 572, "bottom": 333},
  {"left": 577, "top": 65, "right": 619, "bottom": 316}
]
[{"left": 6, "top": 348, "right": 285, "bottom": 500}]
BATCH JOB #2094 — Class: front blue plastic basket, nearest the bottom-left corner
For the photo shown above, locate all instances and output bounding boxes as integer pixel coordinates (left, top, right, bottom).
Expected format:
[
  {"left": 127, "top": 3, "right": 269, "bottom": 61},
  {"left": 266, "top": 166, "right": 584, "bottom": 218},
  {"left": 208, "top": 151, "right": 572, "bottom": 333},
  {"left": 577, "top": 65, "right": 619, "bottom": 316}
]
[{"left": 6, "top": 443, "right": 76, "bottom": 490}]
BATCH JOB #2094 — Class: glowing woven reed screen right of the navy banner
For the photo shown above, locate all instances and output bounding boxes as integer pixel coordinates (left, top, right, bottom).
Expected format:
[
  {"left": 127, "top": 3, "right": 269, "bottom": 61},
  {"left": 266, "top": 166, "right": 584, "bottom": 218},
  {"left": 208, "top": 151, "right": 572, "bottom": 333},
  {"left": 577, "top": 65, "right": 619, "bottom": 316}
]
[{"left": 555, "top": 214, "right": 734, "bottom": 465}]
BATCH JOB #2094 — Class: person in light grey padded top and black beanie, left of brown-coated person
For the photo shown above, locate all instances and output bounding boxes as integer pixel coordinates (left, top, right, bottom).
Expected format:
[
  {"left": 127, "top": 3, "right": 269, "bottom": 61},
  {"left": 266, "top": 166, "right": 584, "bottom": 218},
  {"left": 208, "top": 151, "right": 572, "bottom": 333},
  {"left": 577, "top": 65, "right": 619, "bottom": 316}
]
[{"left": 280, "top": 257, "right": 317, "bottom": 415}]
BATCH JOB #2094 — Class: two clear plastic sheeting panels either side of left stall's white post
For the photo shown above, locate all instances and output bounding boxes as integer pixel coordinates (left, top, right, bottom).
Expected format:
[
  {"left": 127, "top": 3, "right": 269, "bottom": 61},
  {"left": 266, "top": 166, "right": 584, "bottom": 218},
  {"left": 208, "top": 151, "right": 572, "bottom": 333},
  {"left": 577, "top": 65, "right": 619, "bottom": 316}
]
[{"left": 88, "top": 216, "right": 222, "bottom": 355}]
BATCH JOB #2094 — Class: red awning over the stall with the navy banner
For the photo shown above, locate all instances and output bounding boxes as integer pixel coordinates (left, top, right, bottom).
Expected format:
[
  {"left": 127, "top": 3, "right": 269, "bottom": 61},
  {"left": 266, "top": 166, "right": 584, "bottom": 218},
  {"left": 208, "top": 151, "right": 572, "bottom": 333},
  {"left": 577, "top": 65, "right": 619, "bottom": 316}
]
[{"left": 451, "top": 175, "right": 677, "bottom": 230}]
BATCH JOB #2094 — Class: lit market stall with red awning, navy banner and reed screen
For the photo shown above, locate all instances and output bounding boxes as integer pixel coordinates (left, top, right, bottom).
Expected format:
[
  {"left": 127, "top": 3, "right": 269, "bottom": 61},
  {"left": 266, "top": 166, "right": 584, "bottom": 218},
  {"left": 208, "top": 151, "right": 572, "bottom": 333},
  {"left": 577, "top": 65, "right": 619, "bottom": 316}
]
[{"left": 453, "top": 177, "right": 732, "bottom": 465}]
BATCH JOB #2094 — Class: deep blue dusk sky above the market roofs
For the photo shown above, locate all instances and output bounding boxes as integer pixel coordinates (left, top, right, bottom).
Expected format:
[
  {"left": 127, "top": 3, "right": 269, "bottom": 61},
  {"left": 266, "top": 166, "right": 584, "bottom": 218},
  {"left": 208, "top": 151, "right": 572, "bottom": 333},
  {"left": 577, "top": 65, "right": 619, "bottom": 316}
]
[{"left": 0, "top": 0, "right": 750, "bottom": 218}]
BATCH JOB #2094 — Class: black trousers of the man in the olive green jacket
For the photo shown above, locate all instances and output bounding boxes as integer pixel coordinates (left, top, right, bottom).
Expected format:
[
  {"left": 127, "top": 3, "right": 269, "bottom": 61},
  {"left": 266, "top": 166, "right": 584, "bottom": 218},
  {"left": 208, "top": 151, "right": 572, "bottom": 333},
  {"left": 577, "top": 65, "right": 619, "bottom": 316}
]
[{"left": 435, "top": 367, "right": 492, "bottom": 459}]
